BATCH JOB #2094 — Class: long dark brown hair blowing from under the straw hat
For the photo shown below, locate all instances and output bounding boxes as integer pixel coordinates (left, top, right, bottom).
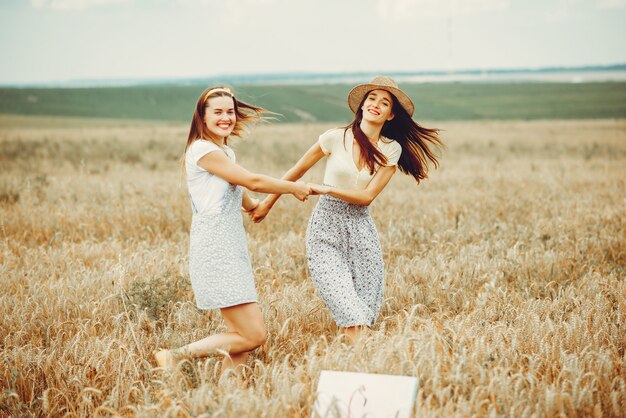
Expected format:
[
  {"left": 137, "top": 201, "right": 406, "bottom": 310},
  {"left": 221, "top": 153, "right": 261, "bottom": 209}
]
[{"left": 344, "top": 93, "right": 445, "bottom": 183}]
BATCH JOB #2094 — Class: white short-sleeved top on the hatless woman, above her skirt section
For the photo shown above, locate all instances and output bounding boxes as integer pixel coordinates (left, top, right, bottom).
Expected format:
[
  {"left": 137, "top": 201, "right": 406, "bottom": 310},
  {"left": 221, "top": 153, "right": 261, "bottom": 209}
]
[{"left": 185, "top": 139, "right": 235, "bottom": 214}]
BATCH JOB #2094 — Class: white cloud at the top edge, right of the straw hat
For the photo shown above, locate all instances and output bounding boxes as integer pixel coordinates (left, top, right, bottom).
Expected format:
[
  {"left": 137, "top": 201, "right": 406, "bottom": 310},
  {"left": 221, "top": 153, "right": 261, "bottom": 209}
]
[{"left": 376, "top": 0, "right": 510, "bottom": 21}]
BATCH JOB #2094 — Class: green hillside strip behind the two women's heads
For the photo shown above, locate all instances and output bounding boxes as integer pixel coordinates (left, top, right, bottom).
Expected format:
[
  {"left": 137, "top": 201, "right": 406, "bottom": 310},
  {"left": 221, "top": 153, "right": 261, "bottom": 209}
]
[{"left": 0, "top": 82, "right": 626, "bottom": 122}]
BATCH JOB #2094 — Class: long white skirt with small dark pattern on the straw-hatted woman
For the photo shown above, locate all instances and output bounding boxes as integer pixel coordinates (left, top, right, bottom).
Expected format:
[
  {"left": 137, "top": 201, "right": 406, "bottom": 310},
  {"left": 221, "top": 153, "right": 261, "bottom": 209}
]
[{"left": 306, "top": 195, "right": 385, "bottom": 327}]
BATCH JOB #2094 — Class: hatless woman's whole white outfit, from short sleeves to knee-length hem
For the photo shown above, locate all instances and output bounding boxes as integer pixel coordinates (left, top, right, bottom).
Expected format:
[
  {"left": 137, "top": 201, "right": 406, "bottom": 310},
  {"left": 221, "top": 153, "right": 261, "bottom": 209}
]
[{"left": 186, "top": 140, "right": 257, "bottom": 309}]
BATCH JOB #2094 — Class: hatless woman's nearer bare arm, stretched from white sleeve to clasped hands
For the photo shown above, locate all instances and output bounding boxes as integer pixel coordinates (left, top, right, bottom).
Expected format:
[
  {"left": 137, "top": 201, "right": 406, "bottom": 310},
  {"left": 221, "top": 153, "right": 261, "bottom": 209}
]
[{"left": 198, "top": 152, "right": 310, "bottom": 201}]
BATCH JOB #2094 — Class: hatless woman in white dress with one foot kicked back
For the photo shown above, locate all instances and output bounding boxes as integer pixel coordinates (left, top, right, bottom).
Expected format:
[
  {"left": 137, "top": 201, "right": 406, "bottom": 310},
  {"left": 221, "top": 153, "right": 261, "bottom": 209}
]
[{"left": 154, "top": 87, "right": 310, "bottom": 367}]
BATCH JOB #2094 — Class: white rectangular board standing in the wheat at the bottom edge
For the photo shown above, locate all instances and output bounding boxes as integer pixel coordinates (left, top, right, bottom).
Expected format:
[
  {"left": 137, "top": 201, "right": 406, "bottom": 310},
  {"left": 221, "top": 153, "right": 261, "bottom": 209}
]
[{"left": 311, "top": 370, "right": 417, "bottom": 418}]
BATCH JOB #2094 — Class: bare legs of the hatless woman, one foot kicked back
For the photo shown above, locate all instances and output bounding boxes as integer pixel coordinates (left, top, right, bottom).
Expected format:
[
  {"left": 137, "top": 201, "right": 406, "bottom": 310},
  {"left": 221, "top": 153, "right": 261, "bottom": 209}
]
[{"left": 154, "top": 302, "right": 267, "bottom": 367}]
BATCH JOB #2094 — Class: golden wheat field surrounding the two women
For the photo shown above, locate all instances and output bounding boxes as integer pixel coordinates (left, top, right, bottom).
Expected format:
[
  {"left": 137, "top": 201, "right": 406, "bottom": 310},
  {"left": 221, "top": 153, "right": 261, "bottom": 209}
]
[{"left": 0, "top": 116, "right": 626, "bottom": 417}]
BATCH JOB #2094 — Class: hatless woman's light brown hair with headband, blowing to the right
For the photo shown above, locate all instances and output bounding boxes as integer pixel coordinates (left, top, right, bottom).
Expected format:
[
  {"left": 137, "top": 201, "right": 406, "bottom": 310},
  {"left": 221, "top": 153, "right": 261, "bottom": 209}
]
[{"left": 182, "top": 86, "right": 273, "bottom": 170}]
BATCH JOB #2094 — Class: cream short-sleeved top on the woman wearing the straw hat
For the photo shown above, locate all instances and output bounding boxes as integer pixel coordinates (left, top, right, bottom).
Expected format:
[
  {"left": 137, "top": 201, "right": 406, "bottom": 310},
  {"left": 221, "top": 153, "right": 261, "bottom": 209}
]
[{"left": 319, "top": 128, "right": 402, "bottom": 190}]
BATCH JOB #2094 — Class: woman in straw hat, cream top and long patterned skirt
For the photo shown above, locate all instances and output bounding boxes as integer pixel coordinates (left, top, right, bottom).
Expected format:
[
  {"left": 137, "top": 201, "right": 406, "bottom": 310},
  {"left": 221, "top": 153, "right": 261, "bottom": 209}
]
[{"left": 250, "top": 76, "right": 442, "bottom": 341}]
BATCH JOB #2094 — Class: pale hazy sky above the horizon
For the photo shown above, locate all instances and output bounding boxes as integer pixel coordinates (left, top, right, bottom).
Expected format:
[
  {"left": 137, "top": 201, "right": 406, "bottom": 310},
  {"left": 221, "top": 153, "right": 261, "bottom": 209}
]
[{"left": 0, "top": 0, "right": 626, "bottom": 84}]
